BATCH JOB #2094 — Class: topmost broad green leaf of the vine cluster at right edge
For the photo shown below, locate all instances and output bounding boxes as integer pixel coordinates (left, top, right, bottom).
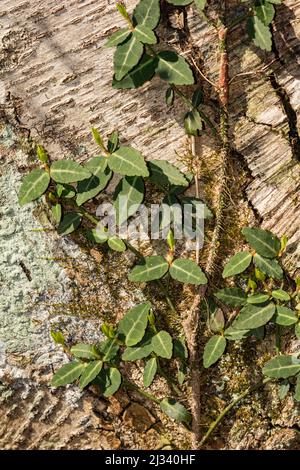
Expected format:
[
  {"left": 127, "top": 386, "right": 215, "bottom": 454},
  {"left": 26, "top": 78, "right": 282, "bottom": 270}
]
[{"left": 242, "top": 227, "right": 280, "bottom": 258}]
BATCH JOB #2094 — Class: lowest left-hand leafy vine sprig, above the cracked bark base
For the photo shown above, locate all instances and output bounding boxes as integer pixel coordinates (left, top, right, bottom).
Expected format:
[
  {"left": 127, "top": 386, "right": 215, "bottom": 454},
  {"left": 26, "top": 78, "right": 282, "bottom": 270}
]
[{"left": 51, "top": 302, "right": 191, "bottom": 425}]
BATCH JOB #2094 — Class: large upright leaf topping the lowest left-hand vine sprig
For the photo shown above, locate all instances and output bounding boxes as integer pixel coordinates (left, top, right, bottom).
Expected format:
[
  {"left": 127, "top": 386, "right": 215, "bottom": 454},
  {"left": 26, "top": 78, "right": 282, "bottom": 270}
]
[{"left": 118, "top": 302, "right": 151, "bottom": 346}]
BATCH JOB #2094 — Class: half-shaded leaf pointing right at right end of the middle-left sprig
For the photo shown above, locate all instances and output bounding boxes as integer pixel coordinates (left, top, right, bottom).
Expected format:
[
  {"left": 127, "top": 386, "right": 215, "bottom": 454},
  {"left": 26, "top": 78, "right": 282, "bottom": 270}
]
[{"left": 148, "top": 160, "right": 189, "bottom": 187}]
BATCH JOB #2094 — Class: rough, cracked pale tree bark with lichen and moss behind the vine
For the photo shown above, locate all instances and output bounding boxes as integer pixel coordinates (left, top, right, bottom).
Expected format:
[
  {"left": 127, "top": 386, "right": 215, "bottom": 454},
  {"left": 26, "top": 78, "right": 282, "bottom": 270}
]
[{"left": 0, "top": 0, "right": 300, "bottom": 449}]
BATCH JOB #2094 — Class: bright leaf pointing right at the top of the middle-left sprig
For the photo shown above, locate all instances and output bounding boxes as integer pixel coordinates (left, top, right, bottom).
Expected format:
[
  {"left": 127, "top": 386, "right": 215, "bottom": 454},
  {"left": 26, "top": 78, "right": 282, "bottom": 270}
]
[{"left": 108, "top": 147, "right": 149, "bottom": 176}]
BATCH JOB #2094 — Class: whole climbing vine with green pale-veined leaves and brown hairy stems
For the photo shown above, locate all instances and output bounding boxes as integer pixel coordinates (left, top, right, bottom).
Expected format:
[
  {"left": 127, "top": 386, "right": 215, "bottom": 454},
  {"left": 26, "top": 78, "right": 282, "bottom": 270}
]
[{"left": 19, "top": 0, "right": 300, "bottom": 448}]
